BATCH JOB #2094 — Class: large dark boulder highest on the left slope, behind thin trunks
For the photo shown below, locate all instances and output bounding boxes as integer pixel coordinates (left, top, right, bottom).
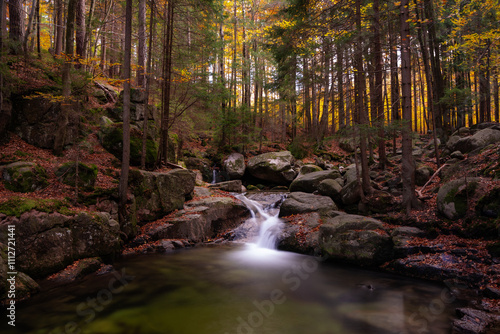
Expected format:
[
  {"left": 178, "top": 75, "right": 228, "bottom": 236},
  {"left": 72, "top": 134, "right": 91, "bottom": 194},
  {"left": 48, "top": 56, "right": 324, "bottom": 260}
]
[{"left": 10, "top": 95, "right": 82, "bottom": 149}]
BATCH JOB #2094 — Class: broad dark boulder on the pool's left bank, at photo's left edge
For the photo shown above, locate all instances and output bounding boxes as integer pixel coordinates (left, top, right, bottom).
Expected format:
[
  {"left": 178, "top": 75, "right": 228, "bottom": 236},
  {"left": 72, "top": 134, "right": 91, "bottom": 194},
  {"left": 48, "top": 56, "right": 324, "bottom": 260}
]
[{"left": 0, "top": 211, "right": 121, "bottom": 278}]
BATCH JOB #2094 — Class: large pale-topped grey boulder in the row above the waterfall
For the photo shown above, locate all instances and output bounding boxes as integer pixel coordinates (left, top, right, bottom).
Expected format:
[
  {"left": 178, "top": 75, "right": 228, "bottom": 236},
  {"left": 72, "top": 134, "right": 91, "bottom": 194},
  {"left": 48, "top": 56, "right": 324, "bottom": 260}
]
[{"left": 247, "top": 151, "right": 297, "bottom": 185}]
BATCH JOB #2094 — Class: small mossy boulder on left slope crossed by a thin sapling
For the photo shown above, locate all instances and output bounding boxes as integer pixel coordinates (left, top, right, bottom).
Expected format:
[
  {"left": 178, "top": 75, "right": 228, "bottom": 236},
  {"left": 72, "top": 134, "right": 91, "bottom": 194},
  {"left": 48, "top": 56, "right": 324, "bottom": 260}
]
[{"left": 56, "top": 162, "right": 98, "bottom": 191}]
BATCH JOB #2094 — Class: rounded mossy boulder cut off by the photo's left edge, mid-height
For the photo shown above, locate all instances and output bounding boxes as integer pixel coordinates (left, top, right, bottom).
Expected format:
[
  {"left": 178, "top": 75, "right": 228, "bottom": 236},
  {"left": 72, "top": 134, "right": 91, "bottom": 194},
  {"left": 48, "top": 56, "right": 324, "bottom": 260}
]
[{"left": 2, "top": 161, "right": 49, "bottom": 193}]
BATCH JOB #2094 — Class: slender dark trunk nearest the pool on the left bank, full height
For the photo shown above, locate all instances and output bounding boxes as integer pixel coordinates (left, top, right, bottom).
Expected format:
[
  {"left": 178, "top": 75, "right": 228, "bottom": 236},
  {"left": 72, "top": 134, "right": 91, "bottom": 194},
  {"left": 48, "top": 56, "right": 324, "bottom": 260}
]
[{"left": 118, "top": 0, "right": 132, "bottom": 227}]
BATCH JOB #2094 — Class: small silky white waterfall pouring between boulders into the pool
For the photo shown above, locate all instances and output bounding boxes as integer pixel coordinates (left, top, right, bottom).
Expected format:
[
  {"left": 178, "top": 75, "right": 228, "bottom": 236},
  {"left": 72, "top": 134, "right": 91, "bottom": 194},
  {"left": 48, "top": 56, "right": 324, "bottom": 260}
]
[{"left": 232, "top": 195, "right": 283, "bottom": 249}]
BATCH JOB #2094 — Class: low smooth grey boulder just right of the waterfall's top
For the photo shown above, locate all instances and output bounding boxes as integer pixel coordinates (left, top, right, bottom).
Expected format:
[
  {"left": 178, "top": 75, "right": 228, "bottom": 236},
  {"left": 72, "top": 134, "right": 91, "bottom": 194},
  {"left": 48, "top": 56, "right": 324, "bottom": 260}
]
[{"left": 279, "top": 192, "right": 337, "bottom": 217}]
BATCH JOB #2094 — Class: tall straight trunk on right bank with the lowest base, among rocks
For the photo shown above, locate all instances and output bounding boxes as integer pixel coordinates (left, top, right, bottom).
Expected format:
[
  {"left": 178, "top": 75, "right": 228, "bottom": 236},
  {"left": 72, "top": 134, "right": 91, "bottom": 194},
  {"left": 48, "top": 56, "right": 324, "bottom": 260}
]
[{"left": 400, "top": 0, "right": 416, "bottom": 214}]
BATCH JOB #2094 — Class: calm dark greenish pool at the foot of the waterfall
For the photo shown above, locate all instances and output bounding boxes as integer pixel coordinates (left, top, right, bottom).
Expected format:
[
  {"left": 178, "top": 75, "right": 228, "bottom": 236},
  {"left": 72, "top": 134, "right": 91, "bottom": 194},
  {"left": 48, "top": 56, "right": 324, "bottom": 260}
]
[{"left": 0, "top": 244, "right": 456, "bottom": 334}]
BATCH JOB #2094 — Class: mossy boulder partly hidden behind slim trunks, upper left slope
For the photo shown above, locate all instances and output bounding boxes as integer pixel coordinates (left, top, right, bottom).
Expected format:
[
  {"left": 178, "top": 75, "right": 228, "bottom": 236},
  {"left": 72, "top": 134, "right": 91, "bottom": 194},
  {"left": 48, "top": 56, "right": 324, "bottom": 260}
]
[{"left": 99, "top": 123, "right": 158, "bottom": 166}]
